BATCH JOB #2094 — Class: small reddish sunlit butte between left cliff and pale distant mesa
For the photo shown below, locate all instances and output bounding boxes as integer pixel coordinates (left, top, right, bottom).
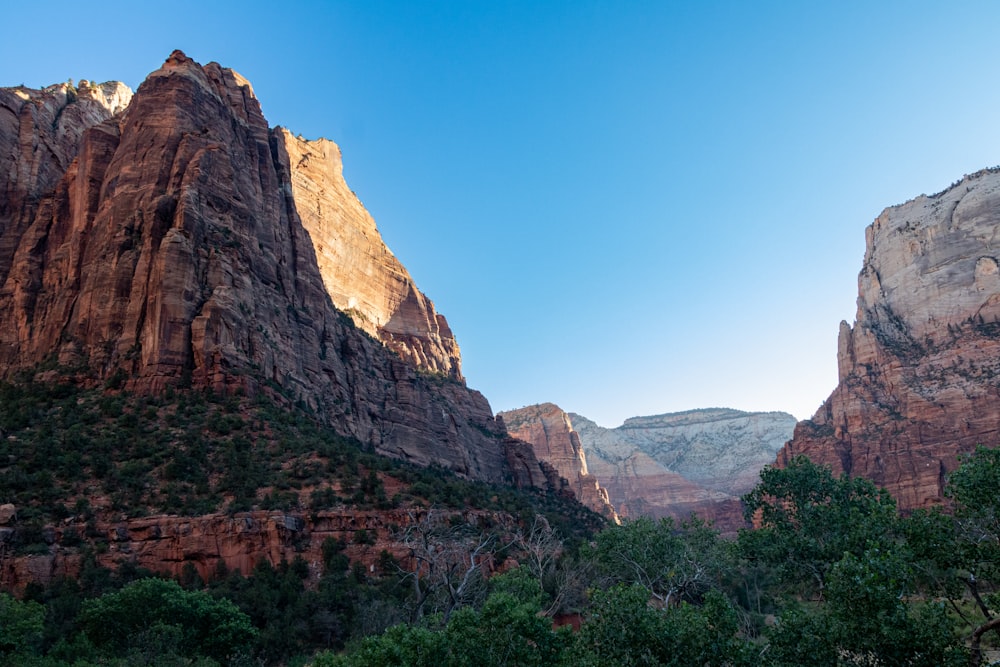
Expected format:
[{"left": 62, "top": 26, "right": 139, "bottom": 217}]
[{"left": 497, "top": 403, "right": 618, "bottom": 521}]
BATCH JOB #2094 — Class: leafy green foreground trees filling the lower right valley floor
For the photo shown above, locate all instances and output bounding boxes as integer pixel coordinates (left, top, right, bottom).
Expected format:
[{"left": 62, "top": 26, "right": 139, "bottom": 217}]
[{"left": 315, "top": 449, "right": 1000, "bottom": 667}]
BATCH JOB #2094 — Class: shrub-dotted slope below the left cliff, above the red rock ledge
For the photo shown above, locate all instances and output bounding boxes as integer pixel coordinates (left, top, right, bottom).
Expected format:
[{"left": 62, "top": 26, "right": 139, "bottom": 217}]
[{"left": 0, "top": 382, "right": 602, "bottom": 553}]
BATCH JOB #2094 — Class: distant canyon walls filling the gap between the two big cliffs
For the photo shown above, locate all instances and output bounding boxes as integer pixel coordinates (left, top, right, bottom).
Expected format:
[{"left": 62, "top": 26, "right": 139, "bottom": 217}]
[{"left": 498, "top": 403, "right": 795, "bottom": 532}]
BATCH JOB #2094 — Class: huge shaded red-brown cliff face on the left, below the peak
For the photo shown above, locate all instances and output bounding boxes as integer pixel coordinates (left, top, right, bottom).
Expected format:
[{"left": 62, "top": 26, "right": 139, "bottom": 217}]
[{"left": 0, "top": 52, "right": 545, "bottom": 486}]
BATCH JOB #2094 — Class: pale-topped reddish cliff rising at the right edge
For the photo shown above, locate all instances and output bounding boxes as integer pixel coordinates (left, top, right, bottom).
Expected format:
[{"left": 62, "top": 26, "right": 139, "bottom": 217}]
[{"left": 778, "top": 169, "right": 1000, "bottom": 510}]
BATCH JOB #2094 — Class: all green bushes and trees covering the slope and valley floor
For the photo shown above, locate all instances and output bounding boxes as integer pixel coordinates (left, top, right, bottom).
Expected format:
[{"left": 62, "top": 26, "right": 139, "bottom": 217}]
[{"left": 0, "top": 378, "right": 1000, "bottom": 667}]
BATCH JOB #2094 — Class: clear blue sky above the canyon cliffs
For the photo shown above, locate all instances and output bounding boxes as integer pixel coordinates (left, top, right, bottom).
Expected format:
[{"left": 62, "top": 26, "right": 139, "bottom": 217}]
[{"left": 0, "top": 0, "right": 1000, "bottom": 426}]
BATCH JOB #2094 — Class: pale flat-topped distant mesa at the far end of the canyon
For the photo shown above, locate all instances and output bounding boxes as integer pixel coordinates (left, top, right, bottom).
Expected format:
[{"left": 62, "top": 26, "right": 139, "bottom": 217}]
[{"left": 570, "top": 409, "right": 795, "bottom": 529}]
